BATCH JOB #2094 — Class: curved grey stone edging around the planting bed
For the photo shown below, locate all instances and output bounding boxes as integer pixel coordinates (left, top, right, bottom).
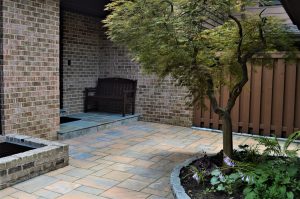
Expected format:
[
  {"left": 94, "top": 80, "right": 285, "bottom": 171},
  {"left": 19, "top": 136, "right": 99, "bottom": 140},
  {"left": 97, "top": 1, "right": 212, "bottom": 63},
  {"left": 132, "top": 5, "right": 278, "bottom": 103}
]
[{"left": 170, "top": 154, "right": 204, "bottom": 199}]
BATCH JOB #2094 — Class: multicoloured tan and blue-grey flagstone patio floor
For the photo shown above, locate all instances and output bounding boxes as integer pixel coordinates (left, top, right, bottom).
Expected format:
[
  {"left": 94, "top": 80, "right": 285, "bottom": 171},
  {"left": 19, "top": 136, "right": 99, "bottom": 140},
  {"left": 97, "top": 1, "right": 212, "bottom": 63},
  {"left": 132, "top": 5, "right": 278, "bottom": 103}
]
[{"left": 0, "top": 122, "right": 284, "bottom": 199}]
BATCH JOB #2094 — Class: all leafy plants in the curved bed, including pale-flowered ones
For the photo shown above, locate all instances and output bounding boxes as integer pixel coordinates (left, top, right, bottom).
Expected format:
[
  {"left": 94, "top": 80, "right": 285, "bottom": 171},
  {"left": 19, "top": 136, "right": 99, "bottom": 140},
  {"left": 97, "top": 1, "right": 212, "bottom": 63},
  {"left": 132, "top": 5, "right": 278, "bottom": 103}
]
[{"left": 211, "top": 131, "right": 300, "bottom": 199}]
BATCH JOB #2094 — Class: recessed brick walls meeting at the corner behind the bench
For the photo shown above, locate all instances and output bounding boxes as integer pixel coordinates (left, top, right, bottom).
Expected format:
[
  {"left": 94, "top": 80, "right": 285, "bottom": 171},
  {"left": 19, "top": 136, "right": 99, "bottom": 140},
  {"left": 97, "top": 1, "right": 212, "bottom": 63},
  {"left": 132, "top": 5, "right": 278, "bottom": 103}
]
[{"left": 63, "top": 12, "right": 192, "bottom": 126}]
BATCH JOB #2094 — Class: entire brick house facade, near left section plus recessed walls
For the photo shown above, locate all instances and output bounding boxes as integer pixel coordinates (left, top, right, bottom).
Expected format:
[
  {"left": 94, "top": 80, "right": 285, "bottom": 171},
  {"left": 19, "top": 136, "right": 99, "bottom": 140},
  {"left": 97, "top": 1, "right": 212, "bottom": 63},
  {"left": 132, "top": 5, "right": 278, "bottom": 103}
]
[{"left": 0, "top": 0, "right": 192, "bottom": 139}]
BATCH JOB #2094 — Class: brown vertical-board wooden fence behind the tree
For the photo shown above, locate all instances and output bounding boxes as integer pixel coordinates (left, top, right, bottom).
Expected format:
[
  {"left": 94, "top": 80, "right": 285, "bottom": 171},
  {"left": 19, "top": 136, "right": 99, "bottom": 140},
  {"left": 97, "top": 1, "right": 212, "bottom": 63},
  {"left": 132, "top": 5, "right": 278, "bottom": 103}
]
[{"left": 193, "top": 54, "right": 300, "bottom": 137}]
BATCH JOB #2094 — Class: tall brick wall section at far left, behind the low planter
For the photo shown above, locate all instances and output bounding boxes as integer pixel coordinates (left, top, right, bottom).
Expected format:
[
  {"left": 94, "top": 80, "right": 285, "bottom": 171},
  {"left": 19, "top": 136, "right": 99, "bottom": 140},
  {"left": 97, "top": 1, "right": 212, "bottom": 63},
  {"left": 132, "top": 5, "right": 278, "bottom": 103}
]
[{"left": 1, "top": 0, "right": 59, "bottom": 139}]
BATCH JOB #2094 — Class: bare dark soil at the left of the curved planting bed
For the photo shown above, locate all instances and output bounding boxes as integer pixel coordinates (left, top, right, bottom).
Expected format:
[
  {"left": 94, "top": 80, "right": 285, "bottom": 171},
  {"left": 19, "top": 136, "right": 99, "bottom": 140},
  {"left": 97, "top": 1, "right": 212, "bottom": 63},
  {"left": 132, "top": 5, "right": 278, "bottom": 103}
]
[{"left": 179, "top": 151, "right": 243, "bottom": 199}]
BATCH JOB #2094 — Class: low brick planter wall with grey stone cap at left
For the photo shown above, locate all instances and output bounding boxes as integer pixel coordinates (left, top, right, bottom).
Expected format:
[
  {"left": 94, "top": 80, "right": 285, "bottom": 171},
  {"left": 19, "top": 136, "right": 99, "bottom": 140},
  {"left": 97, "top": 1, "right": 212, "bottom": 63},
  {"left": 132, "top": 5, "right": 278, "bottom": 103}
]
[{"left": 0, "top": 134, "right": 69, "bottom": 189}]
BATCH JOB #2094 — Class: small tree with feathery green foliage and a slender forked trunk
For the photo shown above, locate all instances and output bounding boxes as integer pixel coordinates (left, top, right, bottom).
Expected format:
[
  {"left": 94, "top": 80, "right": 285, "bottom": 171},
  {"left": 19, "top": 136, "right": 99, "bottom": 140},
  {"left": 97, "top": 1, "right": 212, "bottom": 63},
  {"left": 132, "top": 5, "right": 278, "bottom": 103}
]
[{"left": 104, "top": 0, "right": 293, "bottom": 158}]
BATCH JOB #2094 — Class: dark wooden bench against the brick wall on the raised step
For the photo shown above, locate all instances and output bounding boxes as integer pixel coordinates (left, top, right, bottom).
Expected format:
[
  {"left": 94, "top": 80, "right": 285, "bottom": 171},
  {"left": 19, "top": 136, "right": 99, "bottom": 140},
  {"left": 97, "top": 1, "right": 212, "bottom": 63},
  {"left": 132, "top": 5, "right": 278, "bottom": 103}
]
[{"left": 84, "top": 78, "right": 137, "bottom": 117}]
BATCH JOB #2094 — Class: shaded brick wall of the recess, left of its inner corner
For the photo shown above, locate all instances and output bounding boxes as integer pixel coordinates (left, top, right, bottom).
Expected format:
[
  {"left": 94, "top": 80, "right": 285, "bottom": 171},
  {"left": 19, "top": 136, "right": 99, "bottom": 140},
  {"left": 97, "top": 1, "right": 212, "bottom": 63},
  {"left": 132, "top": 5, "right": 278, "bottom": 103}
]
[{"left": 62, "top": 11, "right": 101, "bottom": 113}]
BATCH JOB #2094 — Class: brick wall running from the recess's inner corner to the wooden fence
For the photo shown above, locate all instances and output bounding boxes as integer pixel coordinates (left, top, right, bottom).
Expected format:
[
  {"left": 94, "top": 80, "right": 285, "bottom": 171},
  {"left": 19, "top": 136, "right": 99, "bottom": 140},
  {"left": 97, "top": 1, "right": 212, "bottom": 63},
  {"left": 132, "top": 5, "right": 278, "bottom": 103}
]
[{"left": 99, "top": 26, "right": 193, "bottom": 126}]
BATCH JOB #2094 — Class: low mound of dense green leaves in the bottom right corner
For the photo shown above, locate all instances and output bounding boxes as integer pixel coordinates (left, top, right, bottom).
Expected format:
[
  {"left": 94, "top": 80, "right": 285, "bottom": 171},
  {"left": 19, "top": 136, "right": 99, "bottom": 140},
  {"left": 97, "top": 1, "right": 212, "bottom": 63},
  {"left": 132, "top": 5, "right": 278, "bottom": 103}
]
[{"left": 243, "top": 160, "right": 300, "bottom": 199}]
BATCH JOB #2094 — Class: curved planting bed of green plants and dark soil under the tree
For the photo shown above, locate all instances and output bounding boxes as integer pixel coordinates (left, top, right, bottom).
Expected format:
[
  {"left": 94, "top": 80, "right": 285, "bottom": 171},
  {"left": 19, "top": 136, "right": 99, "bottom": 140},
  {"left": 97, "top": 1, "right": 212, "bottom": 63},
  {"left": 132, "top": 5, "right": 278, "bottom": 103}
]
[{"left": 180, "top": 132, "right": 300, "bottom": 199}]
